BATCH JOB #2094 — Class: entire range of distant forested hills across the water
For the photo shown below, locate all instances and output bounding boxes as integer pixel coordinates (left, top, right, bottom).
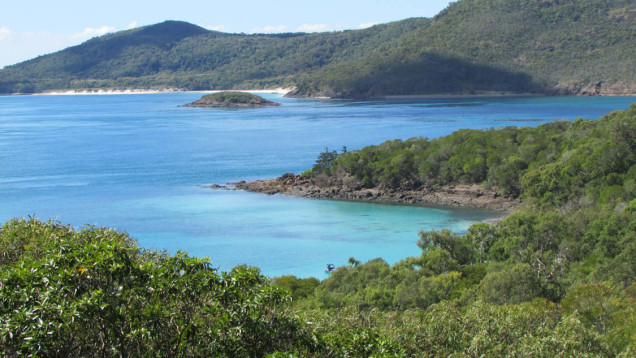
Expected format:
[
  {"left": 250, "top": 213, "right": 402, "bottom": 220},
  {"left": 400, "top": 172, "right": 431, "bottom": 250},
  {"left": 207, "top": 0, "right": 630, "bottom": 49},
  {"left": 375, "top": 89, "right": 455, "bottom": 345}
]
[{"left": 0, "top": 0, "right": 636, "bottom": 97}]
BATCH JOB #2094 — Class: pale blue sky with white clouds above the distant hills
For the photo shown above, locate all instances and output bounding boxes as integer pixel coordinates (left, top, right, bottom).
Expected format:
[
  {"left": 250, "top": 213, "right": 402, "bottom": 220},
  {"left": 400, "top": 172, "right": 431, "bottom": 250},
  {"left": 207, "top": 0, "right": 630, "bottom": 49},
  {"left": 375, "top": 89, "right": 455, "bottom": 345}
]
[{"left": 0, "top": 0, "right": 451, "bottom": 68}]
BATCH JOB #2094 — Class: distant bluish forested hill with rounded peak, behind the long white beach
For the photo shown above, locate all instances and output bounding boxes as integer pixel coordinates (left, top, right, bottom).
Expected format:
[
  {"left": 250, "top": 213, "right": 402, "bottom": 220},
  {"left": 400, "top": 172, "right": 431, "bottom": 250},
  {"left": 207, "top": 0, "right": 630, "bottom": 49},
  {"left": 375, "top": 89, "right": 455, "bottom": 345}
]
[{"left": 0, "top": 18, "right": 430, "bottom": 93}]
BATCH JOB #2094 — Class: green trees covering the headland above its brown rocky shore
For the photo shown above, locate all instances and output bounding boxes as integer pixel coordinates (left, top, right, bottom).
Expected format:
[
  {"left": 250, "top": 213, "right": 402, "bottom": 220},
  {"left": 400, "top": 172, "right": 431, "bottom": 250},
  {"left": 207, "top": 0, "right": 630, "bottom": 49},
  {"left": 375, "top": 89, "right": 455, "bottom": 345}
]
[{"left": 305, "top": 105, "right": 636, "bottom": 206}]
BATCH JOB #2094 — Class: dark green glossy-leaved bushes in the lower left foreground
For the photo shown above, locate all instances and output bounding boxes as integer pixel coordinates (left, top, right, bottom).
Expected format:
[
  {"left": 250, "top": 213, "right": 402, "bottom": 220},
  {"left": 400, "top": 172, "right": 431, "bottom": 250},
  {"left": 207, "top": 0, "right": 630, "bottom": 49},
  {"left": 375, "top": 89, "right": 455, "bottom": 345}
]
[{"left": 0, "top": 219, "right": 312, "bottom": 357}]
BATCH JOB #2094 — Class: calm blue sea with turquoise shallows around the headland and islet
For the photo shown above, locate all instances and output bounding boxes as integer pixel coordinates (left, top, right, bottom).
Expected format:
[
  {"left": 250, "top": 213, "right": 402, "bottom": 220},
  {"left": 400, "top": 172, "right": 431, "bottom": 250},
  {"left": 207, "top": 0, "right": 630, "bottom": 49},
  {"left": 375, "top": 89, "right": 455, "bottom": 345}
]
[{"left": 0, "top": 93, "right": 636, "bottom": 278}]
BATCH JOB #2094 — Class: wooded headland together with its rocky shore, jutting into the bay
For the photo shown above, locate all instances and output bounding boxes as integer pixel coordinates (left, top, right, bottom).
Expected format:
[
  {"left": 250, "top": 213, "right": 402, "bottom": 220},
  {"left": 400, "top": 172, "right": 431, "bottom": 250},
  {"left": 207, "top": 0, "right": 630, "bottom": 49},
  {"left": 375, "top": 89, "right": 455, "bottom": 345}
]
[{"left": 233, "top": 100, "right": 636, "bottom": 211}]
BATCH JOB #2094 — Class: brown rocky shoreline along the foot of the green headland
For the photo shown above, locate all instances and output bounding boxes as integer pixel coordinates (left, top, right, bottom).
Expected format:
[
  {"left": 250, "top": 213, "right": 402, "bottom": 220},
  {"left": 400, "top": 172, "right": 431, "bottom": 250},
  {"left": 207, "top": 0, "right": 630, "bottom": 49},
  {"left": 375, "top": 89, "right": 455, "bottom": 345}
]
[{"left": 221, "top": 173, "right": 521, "bottom": 212}]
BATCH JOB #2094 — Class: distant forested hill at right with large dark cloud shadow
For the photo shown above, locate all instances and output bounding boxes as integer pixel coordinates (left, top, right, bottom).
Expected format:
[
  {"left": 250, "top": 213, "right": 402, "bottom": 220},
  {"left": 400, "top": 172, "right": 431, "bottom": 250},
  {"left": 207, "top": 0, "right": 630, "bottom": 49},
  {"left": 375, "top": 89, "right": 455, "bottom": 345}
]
[{"left": 298, "top": 0, "right": 636, "bottom": 97}]
